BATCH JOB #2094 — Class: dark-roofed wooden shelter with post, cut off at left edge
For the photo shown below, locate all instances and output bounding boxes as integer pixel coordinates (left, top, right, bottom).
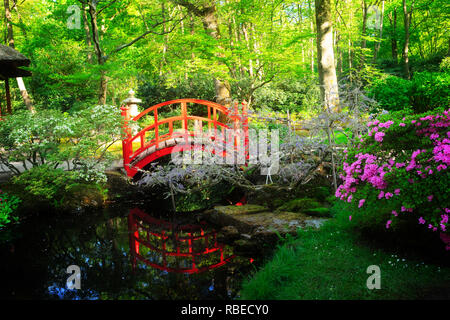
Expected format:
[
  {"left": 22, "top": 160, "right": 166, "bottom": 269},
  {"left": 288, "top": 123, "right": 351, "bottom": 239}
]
[{"left": 0, "top": 44, "right": 31, "bottom": 117}]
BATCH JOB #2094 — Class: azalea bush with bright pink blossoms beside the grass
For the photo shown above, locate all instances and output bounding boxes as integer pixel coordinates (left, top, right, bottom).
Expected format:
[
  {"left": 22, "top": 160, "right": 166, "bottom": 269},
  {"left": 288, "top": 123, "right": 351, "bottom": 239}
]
[{"left": 335, "top": 108, "right": 450, "bottom": 245}]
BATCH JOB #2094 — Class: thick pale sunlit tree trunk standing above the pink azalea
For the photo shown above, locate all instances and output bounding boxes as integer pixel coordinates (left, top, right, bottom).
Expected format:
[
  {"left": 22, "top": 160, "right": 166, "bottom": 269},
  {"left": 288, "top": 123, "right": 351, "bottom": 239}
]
[{"left": 315, "top": 0, "right": 339, "bottom": 110}]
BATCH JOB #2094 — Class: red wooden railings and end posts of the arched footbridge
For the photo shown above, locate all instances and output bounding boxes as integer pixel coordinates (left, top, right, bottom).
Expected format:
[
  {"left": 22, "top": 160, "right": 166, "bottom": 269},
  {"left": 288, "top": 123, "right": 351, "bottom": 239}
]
[{"left": 121, "top": 99, "right": 248, "bottom": 175}]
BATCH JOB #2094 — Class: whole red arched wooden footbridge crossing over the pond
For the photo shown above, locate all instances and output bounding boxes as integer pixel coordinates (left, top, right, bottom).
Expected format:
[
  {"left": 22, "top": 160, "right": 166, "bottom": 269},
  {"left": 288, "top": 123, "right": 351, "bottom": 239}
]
[{"left": 121, "top": 99, "right": 248, "bottom": 177}]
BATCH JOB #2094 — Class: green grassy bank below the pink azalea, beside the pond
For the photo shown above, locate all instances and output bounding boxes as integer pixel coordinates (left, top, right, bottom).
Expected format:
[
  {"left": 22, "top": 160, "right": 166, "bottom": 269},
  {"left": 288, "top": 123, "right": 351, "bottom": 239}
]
[{"left": 241, "top": 220, "right": 450, "bottom": 300}]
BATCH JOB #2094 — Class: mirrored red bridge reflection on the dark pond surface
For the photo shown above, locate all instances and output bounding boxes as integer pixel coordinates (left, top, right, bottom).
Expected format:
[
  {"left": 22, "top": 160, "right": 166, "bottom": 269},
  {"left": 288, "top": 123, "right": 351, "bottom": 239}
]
[{"left": 128, "top": 208, "right": 234, "bottom": 274}]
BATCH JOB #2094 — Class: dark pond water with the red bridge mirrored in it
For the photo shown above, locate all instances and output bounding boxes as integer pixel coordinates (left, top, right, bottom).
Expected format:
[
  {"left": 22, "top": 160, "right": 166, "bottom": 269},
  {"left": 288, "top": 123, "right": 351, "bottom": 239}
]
[{"left": 0, "top": 206, "right": 255, "bottom": 300}]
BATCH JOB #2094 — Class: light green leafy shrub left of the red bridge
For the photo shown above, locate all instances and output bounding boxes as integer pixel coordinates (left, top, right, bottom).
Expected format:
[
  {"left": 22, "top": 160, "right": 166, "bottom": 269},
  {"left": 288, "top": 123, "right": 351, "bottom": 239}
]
[{"left": 0, "top": 106, "right": 123, "bottom": 182}]
